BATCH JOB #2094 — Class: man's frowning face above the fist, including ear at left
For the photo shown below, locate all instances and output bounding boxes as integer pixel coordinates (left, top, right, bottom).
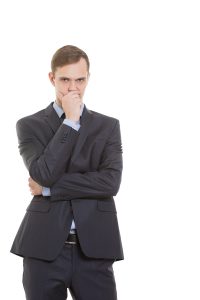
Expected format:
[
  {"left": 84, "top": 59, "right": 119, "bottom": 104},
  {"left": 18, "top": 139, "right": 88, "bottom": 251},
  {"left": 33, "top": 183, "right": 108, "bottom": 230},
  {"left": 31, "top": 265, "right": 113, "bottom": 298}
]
[{"left": 49, "top": 58, "right": 89, "bottom": 106}]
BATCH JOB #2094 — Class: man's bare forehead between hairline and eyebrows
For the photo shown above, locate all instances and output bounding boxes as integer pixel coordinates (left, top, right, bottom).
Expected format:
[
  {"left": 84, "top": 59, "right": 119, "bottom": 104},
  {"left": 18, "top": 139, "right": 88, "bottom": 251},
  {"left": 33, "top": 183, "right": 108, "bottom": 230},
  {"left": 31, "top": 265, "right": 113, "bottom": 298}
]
[{"left": 55, "top": 58, "right": 88, "bottom": 78}]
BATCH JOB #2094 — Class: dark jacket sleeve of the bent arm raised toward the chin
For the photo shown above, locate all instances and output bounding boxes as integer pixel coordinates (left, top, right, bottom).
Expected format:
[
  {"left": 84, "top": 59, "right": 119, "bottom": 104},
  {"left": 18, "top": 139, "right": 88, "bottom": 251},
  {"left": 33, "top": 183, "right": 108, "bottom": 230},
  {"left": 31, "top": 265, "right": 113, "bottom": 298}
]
[{"left": 16, "top": 118, "right": 79, "bottom": 187}]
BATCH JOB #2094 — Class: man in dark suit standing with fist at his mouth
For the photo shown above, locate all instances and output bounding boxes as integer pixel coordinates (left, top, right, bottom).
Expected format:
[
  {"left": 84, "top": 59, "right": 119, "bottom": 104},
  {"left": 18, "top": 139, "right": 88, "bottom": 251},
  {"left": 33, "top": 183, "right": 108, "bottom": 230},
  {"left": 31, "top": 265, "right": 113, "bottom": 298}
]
[{"left": 11, "top": 46, "right": 123, "bottom": 300}]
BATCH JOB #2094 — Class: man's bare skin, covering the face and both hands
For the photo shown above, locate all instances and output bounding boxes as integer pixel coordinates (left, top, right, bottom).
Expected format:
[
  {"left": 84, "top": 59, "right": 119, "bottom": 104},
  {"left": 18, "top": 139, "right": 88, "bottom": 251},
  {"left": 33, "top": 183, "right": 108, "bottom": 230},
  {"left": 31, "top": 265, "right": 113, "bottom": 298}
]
[{"left": 28, "top": 58, "right": 89, "bottom": 196}]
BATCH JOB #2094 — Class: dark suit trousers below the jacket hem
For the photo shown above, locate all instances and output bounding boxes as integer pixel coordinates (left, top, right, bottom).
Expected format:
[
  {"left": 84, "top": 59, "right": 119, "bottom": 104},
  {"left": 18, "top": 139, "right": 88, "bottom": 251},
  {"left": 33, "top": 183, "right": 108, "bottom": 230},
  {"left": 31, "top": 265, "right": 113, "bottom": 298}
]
[{"left": 23, "top": 244, "right": 117, "bottom": 300}]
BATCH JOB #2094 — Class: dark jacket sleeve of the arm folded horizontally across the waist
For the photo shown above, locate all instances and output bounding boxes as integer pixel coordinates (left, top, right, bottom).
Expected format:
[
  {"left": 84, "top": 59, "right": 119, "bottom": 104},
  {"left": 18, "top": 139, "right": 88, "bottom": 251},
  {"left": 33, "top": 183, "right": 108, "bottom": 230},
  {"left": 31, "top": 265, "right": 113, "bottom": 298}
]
[{"left": 51, "top": 120, "right": 122, "bottom": 201}]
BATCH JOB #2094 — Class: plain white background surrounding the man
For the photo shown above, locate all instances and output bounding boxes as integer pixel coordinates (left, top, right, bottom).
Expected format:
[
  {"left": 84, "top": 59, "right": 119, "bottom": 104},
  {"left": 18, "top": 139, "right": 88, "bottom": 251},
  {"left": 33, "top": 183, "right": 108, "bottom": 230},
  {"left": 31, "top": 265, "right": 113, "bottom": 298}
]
[{"left": 0, "top": 0, "right": 200, "bottom": 300}]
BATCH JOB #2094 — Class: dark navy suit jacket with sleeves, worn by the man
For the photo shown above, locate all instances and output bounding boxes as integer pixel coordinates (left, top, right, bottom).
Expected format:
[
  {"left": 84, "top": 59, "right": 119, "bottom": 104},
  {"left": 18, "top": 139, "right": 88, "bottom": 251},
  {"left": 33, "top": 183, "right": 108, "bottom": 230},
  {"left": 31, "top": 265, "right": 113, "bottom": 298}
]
[{"left": 11, "top": 103, "right": 123, "bottom": 260}]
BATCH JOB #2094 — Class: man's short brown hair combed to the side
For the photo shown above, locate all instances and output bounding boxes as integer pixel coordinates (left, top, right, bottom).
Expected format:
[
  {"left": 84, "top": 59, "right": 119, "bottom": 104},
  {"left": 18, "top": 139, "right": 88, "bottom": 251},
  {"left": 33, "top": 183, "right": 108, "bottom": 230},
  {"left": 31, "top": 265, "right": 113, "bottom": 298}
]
[{"left": 51, "top": 45, "right": 90, "bottom": 73}]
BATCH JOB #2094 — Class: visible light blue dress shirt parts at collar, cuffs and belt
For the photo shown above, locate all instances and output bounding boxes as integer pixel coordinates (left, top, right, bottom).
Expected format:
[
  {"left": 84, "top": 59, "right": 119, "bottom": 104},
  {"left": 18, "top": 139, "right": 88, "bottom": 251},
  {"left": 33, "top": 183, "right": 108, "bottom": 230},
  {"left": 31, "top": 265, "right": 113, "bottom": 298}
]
[{"left": 42, "top": 101, "right": 84, "bottom": 231}]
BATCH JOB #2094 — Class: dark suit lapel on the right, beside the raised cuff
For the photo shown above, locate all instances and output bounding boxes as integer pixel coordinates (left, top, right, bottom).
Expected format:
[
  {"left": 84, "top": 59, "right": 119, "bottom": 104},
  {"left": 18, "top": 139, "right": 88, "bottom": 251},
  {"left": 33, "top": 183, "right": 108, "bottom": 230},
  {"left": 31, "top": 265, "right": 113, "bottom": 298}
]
[{"left": 72, "top": 107, "right": 92, "bottom": 161}]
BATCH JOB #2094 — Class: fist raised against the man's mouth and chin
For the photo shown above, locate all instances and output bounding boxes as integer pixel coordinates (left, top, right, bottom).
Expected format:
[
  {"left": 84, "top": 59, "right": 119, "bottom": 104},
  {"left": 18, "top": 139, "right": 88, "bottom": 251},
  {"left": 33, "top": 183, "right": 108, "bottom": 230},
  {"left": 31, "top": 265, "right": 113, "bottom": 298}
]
[{"left": 58, "top": 91, "right": 82, "bottom": 122}]
